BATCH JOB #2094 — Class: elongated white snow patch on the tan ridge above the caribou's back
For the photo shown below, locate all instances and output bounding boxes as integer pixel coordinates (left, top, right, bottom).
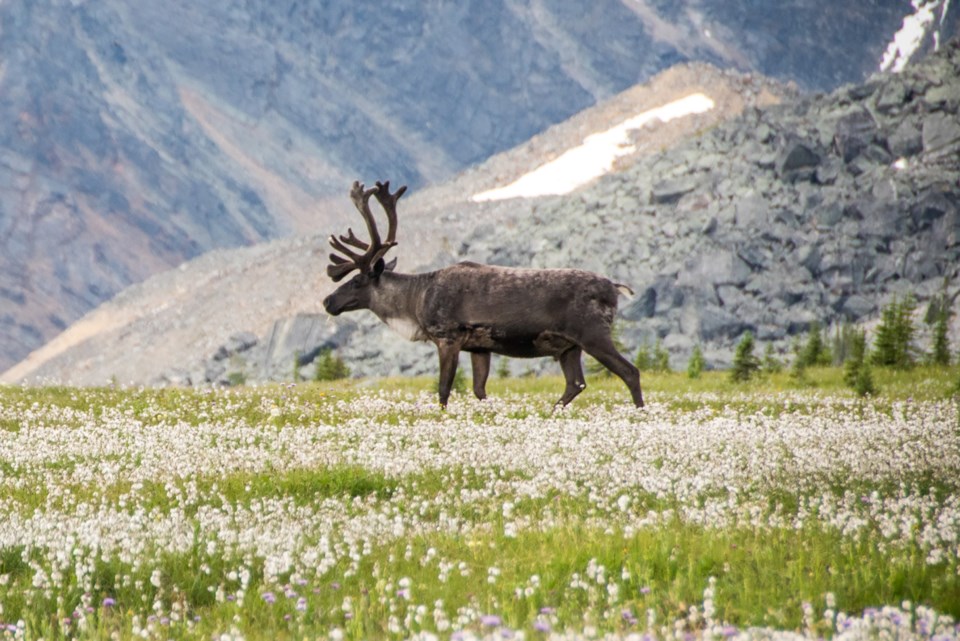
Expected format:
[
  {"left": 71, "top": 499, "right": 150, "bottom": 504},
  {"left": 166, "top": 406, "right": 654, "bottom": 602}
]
[{"left": 471, "top": 93, "right": 714, "bottom": 202}]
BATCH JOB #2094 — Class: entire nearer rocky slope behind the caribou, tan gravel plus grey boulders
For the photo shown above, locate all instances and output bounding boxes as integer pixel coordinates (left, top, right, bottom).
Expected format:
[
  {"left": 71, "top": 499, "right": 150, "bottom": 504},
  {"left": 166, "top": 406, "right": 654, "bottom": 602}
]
[{"left": 4, "top": 41, "right": 960, "bottom": 384}]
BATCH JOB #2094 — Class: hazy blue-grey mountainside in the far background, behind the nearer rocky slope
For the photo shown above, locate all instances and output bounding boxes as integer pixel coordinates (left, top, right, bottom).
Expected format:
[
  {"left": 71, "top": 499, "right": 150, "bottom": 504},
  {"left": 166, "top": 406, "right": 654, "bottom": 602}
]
[{"left": 0, "top": 0, "right": 956, "bottom": 369}]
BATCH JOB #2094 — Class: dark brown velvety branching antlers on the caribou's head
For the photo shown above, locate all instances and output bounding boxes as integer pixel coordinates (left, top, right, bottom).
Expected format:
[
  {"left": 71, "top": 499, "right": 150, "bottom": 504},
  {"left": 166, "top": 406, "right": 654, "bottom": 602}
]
[{"left": 327, "top": 181, "right": 407, "bottom": 282}]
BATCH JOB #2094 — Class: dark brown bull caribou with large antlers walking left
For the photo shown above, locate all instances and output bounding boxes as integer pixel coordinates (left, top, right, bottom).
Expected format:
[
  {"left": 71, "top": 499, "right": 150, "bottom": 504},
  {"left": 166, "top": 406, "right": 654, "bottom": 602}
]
[{"left": 323, "top": 182, "right": 643, "bottom": 407}]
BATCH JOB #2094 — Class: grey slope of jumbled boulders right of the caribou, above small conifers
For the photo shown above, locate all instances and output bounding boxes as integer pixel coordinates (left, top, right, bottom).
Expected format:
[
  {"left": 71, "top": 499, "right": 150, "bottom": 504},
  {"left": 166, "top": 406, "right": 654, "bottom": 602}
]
[{"left": 460, "top": 40, "right": 960, "bottom": 366}]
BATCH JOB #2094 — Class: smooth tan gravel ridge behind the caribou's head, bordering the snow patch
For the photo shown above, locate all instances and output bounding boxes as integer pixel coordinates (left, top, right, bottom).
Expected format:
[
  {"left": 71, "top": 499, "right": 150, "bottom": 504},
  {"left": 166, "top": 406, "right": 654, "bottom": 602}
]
[{"left": 0, "top": 64, "right": 795, "bottom": 385}]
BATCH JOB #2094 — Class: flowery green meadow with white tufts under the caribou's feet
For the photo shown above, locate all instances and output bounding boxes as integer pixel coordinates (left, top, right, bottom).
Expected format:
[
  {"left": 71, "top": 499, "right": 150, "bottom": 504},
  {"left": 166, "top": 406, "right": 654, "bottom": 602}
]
[{"left": 0, "top": 367, "right": 960, "bottom": 641}]
